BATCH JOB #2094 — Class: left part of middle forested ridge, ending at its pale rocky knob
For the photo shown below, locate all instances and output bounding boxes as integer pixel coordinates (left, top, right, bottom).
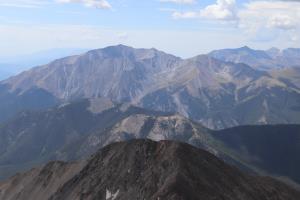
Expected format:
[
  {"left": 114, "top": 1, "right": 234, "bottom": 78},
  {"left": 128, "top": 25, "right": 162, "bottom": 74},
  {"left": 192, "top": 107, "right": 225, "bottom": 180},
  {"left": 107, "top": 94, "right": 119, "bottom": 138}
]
[{"left": 0, "top": 98, "right": 207, "bottom": 178}]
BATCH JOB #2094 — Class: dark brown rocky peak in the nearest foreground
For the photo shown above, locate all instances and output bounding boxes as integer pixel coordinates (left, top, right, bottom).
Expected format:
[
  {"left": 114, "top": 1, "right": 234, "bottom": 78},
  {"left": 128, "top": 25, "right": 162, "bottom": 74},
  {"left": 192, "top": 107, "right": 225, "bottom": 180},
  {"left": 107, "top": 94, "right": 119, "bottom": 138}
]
[{"left": 0, "top": 140, "right": 300, "bottom": 200}]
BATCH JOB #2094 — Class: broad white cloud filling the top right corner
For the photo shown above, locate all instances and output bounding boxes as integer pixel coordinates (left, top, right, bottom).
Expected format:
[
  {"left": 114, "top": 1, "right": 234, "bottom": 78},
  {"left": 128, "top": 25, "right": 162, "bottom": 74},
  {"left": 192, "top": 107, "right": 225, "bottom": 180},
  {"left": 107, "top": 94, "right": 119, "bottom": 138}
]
[{"left": 238, "top": 1, "right": 300, "bottom": 43}]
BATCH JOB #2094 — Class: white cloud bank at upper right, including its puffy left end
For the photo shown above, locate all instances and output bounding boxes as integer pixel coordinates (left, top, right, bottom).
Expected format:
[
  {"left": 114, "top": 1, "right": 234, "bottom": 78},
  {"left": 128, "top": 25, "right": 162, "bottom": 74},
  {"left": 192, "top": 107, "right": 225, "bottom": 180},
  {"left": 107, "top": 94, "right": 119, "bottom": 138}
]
[{"left": 168, "top": 0, "right": 300, "bottom": 40}]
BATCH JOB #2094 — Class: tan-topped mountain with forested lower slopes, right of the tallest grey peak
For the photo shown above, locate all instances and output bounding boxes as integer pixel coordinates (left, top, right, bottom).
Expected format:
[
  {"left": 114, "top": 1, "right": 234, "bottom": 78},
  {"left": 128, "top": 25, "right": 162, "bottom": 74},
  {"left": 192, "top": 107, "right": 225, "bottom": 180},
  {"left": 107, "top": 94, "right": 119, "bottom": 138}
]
[{"left": 140, "top": 56, "right": 300, "bottom": 129}]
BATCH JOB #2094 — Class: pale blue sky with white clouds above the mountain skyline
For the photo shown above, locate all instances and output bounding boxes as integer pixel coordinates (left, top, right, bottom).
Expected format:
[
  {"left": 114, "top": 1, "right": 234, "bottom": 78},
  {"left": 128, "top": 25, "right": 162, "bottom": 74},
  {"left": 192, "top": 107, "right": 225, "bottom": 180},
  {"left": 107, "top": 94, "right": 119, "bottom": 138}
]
[{"left": 0, "top": 0, "right": 300, "bottom": 58}]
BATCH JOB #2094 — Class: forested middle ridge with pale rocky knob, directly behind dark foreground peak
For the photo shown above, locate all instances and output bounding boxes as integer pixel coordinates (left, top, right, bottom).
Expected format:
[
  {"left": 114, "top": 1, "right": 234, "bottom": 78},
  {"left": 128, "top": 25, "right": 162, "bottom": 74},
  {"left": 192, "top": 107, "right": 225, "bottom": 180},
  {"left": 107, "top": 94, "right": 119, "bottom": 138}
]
[{"left": 0, "top": 98, "right": 300, "bottom": 185}]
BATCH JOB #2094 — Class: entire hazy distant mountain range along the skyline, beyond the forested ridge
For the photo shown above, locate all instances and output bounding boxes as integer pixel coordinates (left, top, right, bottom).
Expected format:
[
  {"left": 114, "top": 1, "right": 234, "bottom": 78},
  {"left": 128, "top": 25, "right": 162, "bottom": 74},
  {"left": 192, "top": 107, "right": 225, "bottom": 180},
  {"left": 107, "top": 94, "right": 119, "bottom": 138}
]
[{"left": 0, "top": 45, "right": 300, "bottom": 129}]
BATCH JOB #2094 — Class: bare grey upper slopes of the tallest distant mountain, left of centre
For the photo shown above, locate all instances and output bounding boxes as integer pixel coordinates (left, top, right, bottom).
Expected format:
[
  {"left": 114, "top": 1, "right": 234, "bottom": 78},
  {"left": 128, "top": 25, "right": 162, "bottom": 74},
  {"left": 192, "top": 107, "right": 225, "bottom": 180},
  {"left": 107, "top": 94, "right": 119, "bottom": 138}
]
[{"left": 3, "top": 45, "right": 180, "bottom": 101}]
